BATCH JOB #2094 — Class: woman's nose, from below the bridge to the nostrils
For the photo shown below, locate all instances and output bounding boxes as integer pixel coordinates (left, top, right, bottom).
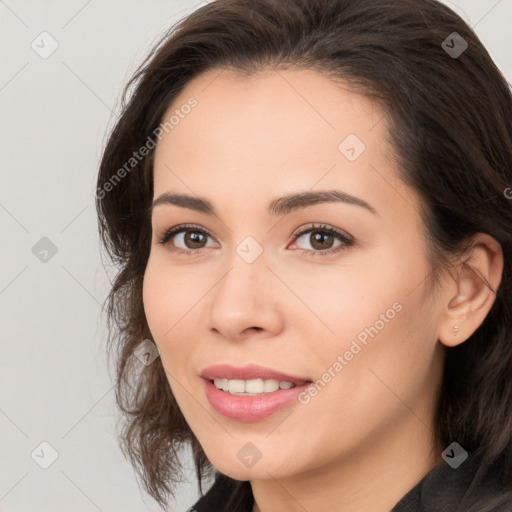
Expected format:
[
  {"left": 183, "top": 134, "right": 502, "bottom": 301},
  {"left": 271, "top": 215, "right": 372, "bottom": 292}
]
[{"left": 206, "top": 247, "right": 285, "bottom": 341}]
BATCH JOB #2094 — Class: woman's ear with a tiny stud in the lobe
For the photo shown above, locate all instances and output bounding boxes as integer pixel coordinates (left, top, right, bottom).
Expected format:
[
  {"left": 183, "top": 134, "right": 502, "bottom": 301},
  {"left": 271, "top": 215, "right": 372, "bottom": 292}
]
[{"left": 438, "top": 233, "right": 503, "bottom": 347}]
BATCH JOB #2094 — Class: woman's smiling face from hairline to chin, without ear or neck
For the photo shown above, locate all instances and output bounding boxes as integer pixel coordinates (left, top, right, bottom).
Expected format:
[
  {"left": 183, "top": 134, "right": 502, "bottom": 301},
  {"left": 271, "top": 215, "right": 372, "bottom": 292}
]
[{"left": 144, "top": 69, "right": 443, "bottom": 480}]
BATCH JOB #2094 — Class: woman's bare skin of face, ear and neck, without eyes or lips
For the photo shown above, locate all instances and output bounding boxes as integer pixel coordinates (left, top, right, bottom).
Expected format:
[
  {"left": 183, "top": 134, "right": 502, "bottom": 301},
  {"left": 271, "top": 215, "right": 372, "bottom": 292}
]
[{"left": 143, "top": 68, "right": 503, "bottom": 512}]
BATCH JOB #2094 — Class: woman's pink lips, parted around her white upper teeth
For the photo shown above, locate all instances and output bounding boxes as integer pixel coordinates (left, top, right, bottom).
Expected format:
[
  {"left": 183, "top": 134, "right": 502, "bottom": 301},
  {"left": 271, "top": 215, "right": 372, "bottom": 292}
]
[{"left": 201, "top": 365, "right": 311, "bottom": 422}]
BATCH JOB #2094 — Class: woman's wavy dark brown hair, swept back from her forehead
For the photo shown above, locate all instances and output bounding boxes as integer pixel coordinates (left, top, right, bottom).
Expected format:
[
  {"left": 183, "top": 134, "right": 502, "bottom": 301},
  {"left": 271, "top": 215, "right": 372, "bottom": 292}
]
[{"left": 96, "top": 0, "right": 512, "bottom": 507}]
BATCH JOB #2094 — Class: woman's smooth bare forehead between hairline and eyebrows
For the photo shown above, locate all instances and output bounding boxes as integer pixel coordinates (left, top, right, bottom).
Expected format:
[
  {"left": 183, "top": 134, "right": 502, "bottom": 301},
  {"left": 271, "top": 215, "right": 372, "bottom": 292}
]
[{"left": 154, "top": 69, "right": 407, "bottom": 218}]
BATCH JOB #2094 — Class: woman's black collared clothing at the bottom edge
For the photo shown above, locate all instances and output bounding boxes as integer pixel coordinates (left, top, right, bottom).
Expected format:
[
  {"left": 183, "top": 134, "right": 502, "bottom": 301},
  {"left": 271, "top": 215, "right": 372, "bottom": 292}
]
[{"left": 189, "top": 456, "right": 512, "bottom": 512}]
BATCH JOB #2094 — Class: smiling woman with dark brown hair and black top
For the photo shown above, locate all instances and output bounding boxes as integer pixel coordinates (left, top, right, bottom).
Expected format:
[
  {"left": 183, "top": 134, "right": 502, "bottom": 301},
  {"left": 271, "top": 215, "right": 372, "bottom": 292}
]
[{"left": 96, "top": 0, "right": 512, "bottom": 512}]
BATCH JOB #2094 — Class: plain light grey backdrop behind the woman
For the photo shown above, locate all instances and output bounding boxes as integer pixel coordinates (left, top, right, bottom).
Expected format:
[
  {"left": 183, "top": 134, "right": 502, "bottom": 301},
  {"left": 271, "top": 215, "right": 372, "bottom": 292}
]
[{"left": 0, "top": 0, "right": 512, "bottom": 512}]
